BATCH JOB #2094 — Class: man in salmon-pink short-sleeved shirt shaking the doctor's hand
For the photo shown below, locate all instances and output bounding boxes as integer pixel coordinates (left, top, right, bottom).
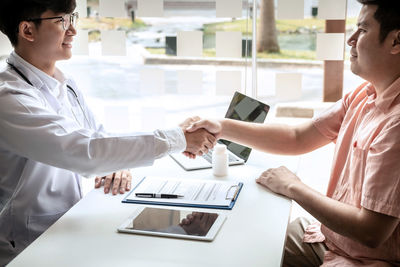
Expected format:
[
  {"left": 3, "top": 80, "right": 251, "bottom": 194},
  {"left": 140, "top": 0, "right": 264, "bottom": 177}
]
[{"left": 189, "top": 0, "right": 400, "bottom": 266}]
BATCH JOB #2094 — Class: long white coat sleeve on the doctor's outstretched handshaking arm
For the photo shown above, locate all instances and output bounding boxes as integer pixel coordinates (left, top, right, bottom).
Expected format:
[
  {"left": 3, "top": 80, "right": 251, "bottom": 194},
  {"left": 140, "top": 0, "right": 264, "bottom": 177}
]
[{"left": 0, "top": 87, "right": 185, "bottom": 176}]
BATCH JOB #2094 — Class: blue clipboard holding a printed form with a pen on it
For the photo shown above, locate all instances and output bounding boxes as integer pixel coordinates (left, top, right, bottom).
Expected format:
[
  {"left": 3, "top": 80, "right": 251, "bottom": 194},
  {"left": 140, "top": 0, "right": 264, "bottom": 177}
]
[{"left": 122, "top": 177, "right": 243, "bottom": 210}]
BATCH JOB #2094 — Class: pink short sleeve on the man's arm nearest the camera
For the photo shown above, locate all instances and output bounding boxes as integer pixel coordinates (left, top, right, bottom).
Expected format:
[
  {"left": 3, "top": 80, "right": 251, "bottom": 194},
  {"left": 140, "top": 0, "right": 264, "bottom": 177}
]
[{"left": 361, "top": 118, "right": 400, "bottom": 218}]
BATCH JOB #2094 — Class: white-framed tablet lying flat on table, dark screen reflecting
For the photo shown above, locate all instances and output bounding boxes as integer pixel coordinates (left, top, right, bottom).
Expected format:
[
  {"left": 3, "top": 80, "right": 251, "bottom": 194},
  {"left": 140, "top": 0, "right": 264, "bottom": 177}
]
[{"left": 118, "top": 207, "right": 226, "bottom": 241}]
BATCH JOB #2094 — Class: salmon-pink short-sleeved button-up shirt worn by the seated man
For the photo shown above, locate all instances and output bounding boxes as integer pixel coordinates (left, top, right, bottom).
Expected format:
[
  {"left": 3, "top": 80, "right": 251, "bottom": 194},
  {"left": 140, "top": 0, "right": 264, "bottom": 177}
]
[{"left": 304, "top": 78, "right": 400, "bottom": 266}]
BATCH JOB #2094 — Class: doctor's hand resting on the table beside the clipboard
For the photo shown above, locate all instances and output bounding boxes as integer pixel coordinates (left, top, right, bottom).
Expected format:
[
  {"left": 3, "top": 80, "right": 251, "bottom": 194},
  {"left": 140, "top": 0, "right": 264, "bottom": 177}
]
[{"left": 94, "top": 170, "right": 132, "bottom": 195}]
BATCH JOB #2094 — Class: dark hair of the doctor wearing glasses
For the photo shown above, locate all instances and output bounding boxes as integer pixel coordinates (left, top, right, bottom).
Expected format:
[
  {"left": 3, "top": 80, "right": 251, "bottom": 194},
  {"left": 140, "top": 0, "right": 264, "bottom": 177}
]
[{"left": 0, "top": 0, "right": 76, "bottom": 47}]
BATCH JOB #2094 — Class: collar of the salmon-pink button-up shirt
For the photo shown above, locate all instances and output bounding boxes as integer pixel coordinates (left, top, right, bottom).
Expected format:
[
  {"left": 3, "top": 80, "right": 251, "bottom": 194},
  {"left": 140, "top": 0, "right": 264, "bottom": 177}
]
[{"left": 367, "top": 77, "right": 400, "bottom": 113}]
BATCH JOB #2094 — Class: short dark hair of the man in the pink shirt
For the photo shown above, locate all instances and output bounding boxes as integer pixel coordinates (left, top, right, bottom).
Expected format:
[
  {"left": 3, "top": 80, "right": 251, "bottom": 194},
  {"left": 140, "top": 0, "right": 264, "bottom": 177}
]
[{"left": 357, "top": 0, "right": 400, "bottom": 43}]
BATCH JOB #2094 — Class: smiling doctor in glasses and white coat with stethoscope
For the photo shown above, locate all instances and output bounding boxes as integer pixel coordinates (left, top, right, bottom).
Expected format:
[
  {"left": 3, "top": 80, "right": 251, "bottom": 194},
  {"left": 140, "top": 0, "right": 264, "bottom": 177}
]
[{"left": 0, "top": 0, "right": 215, "bottom": 266}]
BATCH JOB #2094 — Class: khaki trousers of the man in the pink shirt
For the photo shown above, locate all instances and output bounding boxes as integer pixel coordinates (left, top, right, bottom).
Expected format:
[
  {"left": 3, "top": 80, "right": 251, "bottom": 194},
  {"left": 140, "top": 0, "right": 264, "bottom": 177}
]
[{"left": 282, "top": 218, "right": 328, "bottom": 267}]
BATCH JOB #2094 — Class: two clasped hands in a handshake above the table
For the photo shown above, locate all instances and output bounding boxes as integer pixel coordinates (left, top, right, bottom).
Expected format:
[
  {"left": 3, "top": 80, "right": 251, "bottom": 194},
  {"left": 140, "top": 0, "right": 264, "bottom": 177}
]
[{"left": 179, "top": 116, "right": 222, "bottom": 158}]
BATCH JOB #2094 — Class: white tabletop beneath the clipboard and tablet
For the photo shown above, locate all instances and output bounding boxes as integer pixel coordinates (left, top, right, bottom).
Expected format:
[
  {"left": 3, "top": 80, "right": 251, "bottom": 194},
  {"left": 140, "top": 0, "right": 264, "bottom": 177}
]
[{"left": 9, "top": 152, "right": 297, "bottom": 267}]
